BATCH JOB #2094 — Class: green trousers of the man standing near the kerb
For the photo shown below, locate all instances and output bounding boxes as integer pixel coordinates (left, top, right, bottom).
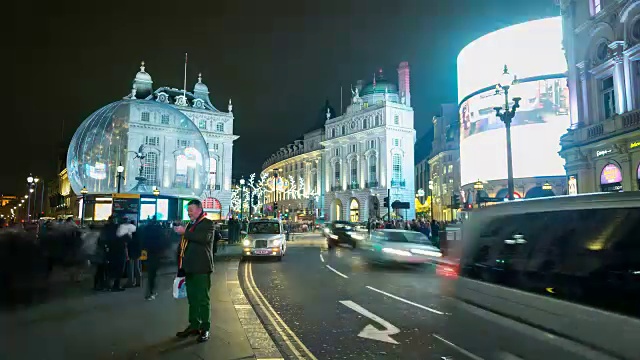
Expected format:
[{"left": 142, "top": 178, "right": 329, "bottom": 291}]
[{"left": 185, "top": 273, "right": 211, "bottom": 331}]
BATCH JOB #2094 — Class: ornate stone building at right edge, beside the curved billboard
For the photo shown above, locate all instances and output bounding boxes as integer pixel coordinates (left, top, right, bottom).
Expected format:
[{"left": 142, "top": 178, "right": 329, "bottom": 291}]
[{"left": 560, "top": 0, "right": 640, "bottom": 194}]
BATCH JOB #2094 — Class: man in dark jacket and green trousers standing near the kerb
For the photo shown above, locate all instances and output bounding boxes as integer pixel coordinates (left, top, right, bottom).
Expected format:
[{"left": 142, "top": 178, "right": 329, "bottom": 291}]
[{"left": 174, "top": 200, "right": 219, "bottom": 342}]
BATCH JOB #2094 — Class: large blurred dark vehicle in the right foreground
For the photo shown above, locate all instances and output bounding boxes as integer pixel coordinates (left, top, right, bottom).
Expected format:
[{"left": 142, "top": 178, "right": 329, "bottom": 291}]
[{"left": 437, "top": 192, "right": 640, "bottom": 360}]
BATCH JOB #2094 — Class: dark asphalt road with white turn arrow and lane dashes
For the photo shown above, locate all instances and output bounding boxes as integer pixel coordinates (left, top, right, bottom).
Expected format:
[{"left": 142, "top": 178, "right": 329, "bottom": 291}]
[{"left": 240, "top": 236, "right": 467, "bottom": 359}]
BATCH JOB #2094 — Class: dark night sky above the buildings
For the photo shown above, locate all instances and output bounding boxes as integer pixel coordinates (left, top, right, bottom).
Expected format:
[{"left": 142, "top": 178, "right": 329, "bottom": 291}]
[{"left": 5, "top": 0, "right": 559, "bottom": 195}]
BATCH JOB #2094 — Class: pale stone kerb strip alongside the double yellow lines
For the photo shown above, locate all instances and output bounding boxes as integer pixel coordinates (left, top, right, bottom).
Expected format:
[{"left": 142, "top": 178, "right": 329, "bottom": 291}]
[{"left": 225, "top": 259, "right": 284, "bottom": 360}]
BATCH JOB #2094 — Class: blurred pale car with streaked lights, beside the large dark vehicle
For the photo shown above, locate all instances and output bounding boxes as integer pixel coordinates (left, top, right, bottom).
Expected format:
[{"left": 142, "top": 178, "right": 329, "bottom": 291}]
[{"left": 362, "top": 229, "right": 442, "bottom": 264}]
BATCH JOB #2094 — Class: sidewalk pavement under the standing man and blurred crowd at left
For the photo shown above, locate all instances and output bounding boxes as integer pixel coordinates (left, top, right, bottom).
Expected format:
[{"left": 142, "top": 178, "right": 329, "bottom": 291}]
[{"left": 0, "top": 246, "right": 282, "bottom": 360}]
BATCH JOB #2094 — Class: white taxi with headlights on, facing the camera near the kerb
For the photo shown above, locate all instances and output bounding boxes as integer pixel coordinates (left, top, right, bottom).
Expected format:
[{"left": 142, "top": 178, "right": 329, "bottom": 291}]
[{"left": 242, "top": 219, "right": 287, "bottom": 261}]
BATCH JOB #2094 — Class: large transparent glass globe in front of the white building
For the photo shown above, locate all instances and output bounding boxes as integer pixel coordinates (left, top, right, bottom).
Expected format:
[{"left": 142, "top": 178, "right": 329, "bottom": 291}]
[{"left": 67, "top": 100, "right": 209, "bottom": 198}]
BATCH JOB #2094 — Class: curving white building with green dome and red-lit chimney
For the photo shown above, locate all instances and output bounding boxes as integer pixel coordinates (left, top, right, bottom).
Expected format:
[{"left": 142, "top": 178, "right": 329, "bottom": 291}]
[{"left": 263, "top": 62, "right": 416, "bottom": 222}]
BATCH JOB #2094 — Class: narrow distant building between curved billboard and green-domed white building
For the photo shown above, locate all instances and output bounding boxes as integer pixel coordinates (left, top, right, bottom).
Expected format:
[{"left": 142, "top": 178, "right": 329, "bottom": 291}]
[{"left": 429, "top": 104, "right": 460, "bottom": 221}]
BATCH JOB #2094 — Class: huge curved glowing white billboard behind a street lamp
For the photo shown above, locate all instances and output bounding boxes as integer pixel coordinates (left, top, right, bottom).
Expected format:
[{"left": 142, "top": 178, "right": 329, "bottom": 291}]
[{"left": 458, "top": 17, "right": 570, "bottom": 185}]
